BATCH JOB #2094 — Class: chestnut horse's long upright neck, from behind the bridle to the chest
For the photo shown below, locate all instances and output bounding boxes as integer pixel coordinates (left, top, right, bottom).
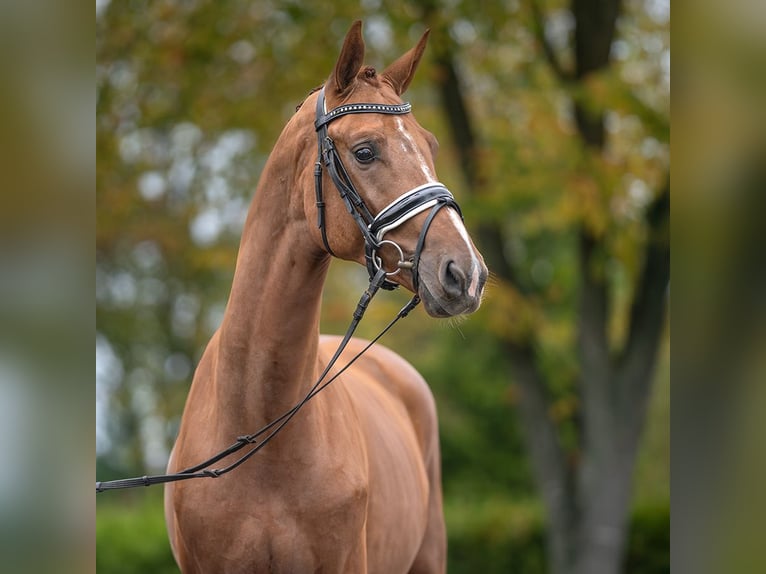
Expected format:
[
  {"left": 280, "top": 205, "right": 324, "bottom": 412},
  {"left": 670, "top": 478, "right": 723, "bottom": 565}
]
[{"left": 215, "top": 126, "right": 329, "bottom": 433}]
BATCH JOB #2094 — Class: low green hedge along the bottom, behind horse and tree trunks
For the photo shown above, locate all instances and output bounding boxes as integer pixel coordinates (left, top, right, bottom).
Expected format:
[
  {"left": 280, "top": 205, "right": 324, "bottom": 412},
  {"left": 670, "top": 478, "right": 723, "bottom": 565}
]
[{"left": 96, "top": 495, "right": 670, "bottom": 574}]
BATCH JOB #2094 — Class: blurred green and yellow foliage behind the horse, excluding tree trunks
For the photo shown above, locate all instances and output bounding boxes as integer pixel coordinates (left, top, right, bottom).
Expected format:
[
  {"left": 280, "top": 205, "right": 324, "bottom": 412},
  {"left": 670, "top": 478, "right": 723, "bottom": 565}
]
[{"left": 96, "top": 0, "right": 669, "bottom": 574}]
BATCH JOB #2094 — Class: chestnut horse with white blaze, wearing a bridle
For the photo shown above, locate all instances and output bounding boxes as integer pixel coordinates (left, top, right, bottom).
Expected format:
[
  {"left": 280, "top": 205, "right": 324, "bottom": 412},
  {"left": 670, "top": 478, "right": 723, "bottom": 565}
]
[{"left": 165, "top": 21, "right": 487, "bottom": 574}]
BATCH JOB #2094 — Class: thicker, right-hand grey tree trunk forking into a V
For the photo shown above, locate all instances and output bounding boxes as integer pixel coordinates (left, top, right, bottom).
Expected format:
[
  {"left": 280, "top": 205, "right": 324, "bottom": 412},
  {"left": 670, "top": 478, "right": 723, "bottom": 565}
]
[{"left": 567, "top": 189, "right": 670, "bottom": 574}]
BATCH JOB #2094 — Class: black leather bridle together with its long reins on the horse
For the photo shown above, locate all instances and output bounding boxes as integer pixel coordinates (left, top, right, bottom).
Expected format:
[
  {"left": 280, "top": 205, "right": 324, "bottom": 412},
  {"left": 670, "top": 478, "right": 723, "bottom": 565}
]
[{"left": 96, "top": 88, "right": 462, "bottom": 493}]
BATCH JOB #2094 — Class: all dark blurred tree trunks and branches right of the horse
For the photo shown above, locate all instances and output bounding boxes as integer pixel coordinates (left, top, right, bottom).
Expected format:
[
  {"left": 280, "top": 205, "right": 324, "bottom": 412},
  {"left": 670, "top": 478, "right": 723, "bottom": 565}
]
[{"left": 423, "top": 0, "right": 670, "bottom": 574}]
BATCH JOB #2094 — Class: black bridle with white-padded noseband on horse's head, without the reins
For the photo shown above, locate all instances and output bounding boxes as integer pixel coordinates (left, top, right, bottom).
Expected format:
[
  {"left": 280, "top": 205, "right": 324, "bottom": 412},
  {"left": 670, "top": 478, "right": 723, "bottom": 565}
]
[{"left": 314, "top": 88, "right": 462, "bottom": 294}]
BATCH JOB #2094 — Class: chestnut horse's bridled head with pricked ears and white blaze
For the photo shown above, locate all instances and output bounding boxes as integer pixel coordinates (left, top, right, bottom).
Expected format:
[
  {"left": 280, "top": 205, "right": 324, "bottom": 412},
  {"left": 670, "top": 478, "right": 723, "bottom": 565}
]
[{"left": 304, "top": 22, "right": 487, "bottom": 317}]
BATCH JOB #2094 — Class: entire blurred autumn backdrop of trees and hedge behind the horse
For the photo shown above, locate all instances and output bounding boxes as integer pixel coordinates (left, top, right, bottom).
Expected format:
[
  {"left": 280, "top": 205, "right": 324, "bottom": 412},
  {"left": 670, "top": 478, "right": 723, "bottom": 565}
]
[{"left": 96, "top": 0, "right": 672, "bottom": 574}]
